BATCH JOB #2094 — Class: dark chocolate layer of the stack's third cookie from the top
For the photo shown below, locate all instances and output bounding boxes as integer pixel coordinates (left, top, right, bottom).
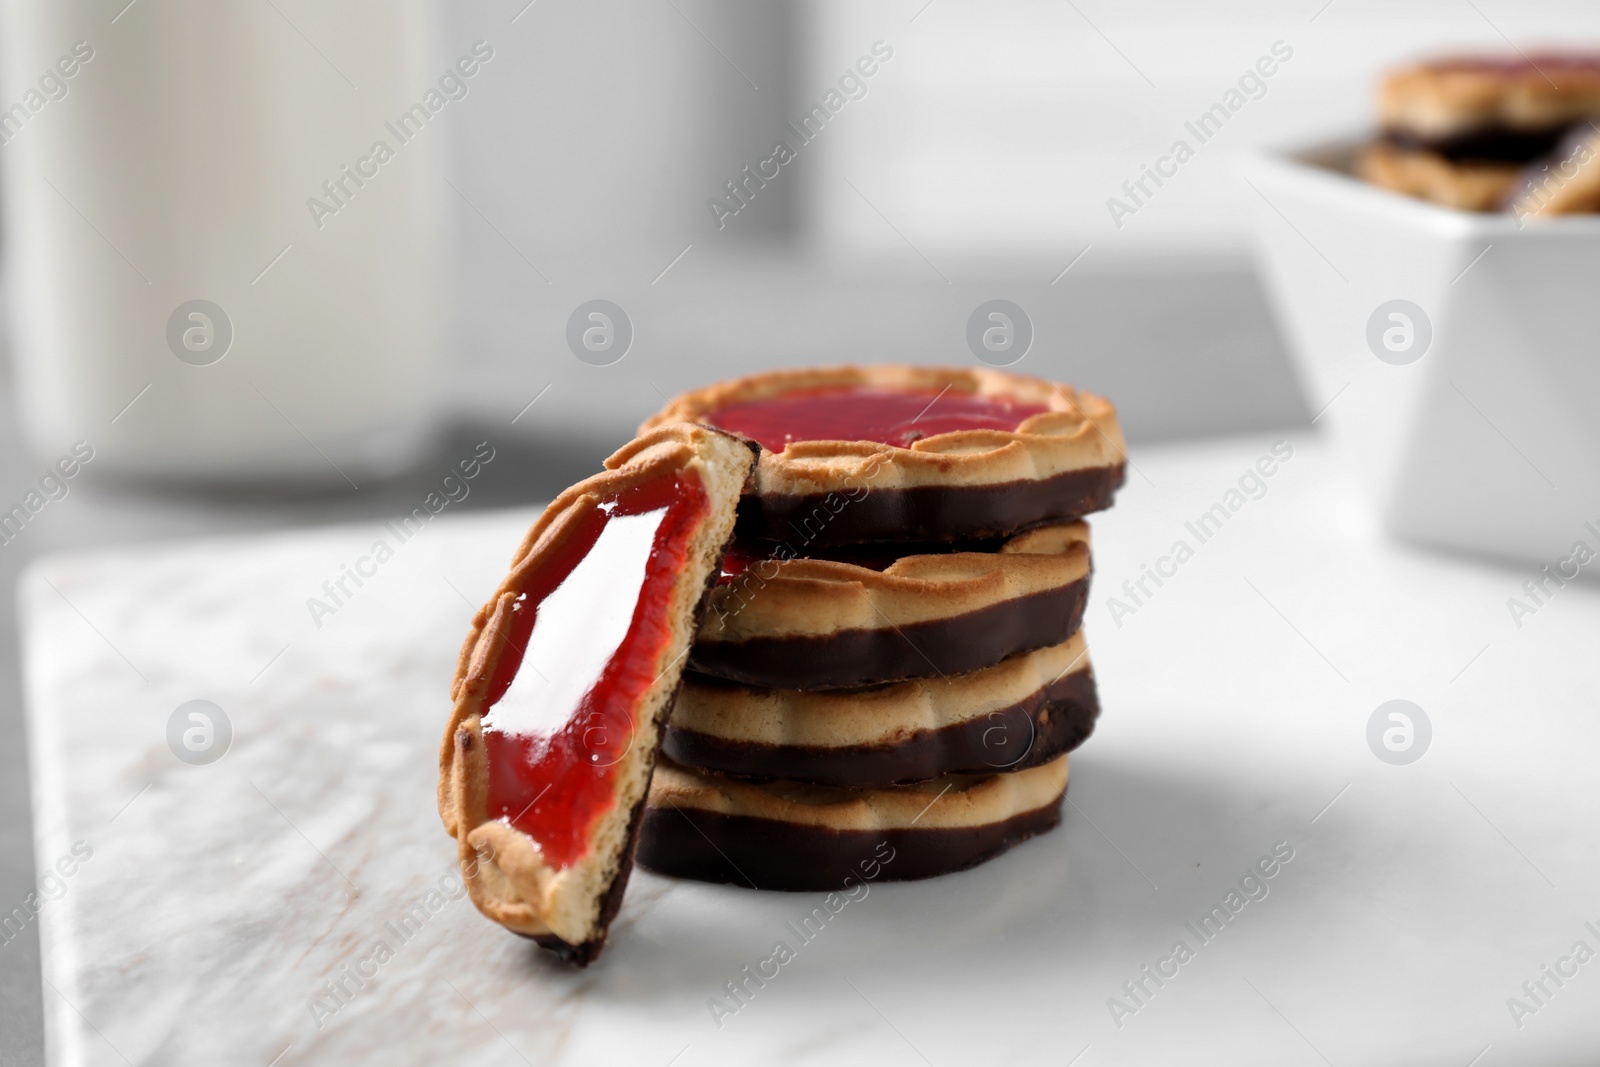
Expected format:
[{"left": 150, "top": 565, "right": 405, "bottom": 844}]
[{"left": 661, "top": 667, "right": 1099, "bottom": 789}]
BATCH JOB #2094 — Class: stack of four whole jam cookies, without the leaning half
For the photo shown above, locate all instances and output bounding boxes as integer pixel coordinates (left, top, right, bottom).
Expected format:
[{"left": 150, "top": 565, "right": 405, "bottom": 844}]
[{"left": 637, "top": 366, "right": 1123, "bottom": 889}]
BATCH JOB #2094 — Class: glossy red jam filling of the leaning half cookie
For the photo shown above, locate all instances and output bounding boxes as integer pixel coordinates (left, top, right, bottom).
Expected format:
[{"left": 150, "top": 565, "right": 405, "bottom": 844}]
[{"left": 483, "top": 472, "right": 707, "bottom": 869}]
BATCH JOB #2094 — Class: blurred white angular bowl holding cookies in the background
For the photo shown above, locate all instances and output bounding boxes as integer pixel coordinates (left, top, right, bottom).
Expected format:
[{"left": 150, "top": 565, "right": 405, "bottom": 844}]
[{"left": 1243, "top": 142, "right": 1600, "bottom": 565}]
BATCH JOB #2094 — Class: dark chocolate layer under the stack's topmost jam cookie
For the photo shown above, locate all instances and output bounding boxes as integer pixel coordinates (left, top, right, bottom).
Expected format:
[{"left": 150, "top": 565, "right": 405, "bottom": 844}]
[{"left": 736, "top": 464, "right": 1125, "bottom": 555}]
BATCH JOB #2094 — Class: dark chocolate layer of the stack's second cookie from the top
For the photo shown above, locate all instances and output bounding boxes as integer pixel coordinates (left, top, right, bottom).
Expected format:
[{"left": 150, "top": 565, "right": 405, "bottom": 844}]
[{"left": 690, "top": 577, "right": 1090, "bottom": 689}]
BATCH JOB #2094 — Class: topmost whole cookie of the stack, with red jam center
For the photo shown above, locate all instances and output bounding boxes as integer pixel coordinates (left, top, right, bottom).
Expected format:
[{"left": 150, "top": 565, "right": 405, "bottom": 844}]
[{"left": 643, "top": 367, "right": 1126, "bottom": 547}]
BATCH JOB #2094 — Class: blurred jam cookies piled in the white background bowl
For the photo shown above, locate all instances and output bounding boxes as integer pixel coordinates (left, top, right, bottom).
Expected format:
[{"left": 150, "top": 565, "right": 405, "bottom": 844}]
[{"left": 1360, "top": 51, "right": 1600, "bottom": 218}]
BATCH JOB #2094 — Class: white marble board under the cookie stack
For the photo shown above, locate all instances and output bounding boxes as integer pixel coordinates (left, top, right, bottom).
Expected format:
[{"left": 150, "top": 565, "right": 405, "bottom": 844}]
[{"left": 21, "top": 438, "right": 1600, "bottom": 1067}]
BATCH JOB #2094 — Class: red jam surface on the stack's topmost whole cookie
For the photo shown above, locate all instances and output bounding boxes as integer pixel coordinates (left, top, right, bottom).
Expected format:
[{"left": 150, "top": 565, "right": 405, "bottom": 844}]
[{"left": 706, "top": 389, "right": 1048, "bottom": 453}]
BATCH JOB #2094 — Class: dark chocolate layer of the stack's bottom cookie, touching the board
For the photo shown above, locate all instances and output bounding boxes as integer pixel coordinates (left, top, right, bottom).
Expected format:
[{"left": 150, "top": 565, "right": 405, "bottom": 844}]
[{"left": 637, "top": 793, "right": 1064, "bottom": 891}]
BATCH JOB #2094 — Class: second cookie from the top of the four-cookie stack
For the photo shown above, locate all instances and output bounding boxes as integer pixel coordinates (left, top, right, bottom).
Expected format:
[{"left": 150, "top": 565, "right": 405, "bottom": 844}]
[{"left": 690, "top": 523, "right": 1090, "bottom": 689}]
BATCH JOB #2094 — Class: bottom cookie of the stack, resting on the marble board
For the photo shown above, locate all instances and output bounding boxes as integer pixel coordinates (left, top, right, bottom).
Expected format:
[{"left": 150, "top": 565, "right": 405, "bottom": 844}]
[{"left": 637, "top": 757, "right": 1069, "bottom": 889}]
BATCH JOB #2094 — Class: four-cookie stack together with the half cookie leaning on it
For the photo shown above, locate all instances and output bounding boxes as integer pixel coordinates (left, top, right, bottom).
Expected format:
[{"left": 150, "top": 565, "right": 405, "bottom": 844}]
[{"left": 438, "top": 366, "right": 1123, "bottom": 965}]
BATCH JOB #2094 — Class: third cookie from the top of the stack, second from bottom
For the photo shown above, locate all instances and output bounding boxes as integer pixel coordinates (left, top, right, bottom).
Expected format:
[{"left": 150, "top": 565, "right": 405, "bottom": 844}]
[{"left": 661, "top": 630, "right": 1099, "bottom": 789}]
